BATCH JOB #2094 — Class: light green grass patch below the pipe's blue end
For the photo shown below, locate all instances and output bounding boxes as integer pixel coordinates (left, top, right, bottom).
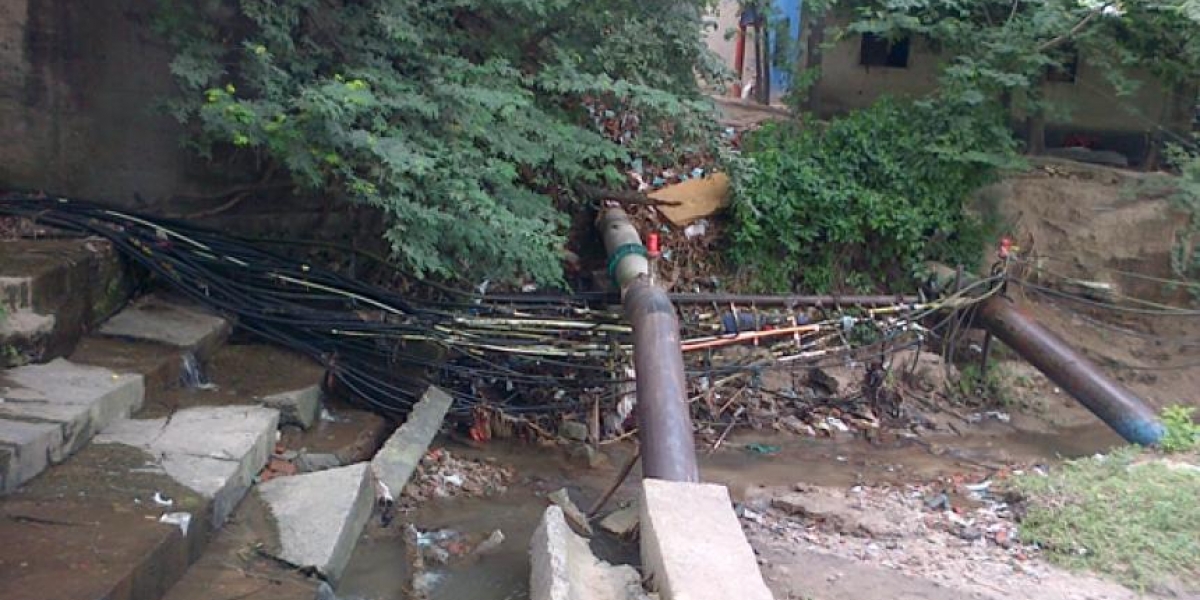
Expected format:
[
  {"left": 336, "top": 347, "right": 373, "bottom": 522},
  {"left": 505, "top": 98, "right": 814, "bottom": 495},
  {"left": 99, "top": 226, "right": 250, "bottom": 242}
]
[{"left": 1013, "top": 448, "right": 1200, "bottom": 590}]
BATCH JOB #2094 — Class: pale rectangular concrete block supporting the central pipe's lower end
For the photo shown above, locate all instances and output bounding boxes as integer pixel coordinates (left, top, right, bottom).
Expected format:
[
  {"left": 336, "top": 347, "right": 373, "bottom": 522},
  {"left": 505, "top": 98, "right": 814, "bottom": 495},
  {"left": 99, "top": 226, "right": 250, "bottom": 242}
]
[{"left": 641, "top": 479, "right": 773, "bottom": 600}]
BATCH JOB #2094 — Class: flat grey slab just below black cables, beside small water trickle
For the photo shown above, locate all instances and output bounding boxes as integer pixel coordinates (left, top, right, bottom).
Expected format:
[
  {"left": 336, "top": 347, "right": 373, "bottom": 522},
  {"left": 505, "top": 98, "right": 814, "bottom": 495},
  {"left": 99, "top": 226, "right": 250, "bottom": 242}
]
[{"left": 100, "top": 295, "right": 232, "bottom": 359}]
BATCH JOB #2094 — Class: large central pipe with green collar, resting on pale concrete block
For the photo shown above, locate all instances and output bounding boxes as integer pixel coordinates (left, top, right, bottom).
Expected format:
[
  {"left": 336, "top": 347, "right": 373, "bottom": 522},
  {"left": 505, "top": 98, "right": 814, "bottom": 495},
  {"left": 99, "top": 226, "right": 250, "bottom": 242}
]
[{"left": 599, "top": 208, "right": 700, "bottom": 481}]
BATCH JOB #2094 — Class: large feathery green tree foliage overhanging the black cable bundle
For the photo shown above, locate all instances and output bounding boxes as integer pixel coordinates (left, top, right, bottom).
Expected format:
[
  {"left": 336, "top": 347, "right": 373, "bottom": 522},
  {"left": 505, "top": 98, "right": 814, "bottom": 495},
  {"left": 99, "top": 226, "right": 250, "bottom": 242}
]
[{"left": 160, "top": 0, "right": 719, "bottom": 283}]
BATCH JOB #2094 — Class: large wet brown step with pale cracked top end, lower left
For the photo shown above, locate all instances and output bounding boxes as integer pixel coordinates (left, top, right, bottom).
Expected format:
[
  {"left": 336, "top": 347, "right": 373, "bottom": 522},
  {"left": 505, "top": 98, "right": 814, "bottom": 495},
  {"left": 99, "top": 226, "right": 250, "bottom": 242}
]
[{"left": 0, "top": 407, "right": 278, "bottom": 600}]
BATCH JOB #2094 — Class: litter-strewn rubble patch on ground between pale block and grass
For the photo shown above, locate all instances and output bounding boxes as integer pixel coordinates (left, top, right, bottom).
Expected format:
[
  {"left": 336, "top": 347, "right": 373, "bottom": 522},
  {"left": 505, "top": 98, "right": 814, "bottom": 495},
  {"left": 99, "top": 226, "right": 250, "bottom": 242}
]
[{"left": 739, "top": 479, "right": 1048, "bottom": 587}]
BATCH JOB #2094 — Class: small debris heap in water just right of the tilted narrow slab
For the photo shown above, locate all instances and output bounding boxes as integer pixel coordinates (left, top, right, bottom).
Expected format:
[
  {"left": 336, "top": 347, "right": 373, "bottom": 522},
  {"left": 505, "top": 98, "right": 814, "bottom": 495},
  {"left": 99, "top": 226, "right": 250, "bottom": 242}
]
[{"left": 401, "top": 448, "right": 515, "bottom": 505}]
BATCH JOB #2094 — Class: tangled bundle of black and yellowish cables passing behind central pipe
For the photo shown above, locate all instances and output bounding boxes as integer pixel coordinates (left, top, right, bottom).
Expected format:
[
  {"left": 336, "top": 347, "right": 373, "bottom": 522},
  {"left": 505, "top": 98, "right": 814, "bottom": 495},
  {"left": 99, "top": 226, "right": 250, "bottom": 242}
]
[{"left": 0, "top": 193, "right": 998, "bottom": 439}]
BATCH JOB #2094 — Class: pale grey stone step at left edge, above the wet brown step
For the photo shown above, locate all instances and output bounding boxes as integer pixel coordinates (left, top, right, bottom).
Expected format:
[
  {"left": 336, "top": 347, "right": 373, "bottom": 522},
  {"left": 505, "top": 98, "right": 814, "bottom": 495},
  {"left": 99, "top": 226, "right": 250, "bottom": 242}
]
[{"left": 0, "top": 359, "right": 145, "bottom": 492}]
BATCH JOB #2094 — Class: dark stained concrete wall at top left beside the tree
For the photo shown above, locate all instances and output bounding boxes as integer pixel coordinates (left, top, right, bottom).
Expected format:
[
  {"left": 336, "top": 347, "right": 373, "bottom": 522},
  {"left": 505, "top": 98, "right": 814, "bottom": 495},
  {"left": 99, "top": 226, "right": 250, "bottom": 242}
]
[{"left": 0, "top": 0, "right": 208, "bottom": 204}]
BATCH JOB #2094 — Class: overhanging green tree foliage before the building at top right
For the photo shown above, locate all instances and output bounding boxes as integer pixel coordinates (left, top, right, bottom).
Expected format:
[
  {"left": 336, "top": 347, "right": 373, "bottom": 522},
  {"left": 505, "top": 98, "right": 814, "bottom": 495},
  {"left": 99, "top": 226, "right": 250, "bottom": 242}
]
[{"left": 846, "top": 0, "right": 1200, "bottom": 137}]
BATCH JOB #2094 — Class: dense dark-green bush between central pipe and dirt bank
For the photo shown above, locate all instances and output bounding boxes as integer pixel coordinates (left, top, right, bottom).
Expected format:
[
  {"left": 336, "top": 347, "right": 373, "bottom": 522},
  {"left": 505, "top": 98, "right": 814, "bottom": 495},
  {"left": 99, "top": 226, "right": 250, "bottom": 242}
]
[{"left": 731, "top": 100, "right": 1015, "bottom": 292}]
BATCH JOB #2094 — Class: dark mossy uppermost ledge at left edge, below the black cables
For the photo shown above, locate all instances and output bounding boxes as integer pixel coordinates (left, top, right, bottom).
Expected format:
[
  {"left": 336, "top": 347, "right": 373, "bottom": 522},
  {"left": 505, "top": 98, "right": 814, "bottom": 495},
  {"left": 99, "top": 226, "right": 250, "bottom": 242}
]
[{"left": 0, "top": 239, "right": 136, "bottom": 366}]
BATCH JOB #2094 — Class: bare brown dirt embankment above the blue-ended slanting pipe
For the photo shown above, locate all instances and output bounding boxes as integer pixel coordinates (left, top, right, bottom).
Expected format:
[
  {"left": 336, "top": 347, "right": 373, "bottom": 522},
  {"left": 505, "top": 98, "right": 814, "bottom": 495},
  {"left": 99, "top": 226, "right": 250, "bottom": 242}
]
[{"left": 979, "top": 160, "right": 1200, "bottom": 408}]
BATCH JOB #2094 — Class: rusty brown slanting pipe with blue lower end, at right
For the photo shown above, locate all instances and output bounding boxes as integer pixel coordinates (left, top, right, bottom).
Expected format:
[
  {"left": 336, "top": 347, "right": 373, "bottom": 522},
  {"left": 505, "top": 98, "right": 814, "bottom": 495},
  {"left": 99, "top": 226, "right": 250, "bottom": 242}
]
[{"left": 977, "top": 296, "right": 1164, "bottom": 445}]
